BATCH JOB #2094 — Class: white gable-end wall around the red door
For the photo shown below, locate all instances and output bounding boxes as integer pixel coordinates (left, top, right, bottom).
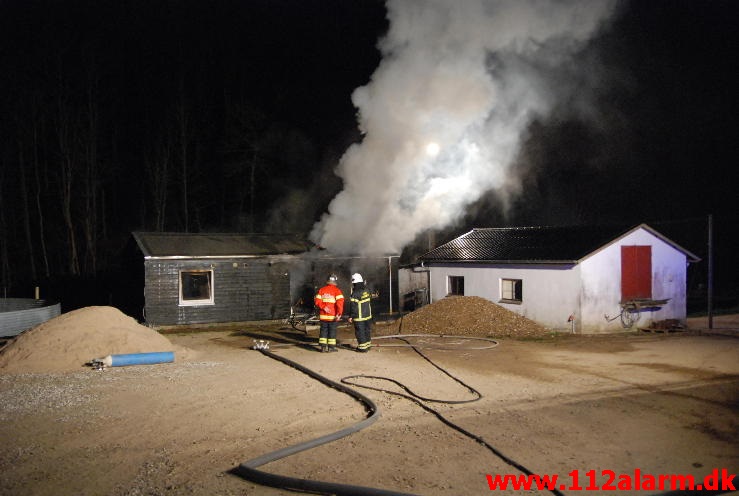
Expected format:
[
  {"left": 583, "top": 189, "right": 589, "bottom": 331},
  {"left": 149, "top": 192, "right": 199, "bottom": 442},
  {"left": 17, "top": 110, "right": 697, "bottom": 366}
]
[{"left": 580, "top": 229, "right": 687, "bottom": 333}]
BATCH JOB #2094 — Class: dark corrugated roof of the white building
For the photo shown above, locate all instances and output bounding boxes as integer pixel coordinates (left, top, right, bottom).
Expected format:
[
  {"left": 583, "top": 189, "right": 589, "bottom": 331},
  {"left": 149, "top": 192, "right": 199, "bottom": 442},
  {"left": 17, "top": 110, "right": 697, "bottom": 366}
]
[{"left": 419, "top": 224, "right": 700, "bottom": 263}]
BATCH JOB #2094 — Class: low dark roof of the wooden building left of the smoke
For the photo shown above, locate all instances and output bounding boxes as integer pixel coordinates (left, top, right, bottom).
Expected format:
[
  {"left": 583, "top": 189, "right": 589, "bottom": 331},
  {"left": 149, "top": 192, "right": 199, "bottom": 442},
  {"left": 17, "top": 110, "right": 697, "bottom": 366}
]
[{"left": 133, "top": 232, "right": 314, "bottom": 258}]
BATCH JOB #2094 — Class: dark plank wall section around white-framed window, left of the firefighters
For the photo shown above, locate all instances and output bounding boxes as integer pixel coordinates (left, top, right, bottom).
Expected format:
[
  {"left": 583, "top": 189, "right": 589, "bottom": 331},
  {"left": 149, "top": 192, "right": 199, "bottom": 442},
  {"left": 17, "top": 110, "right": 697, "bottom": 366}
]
[{"left": 144, "top": 257, "right": 290, "bottom": 325}]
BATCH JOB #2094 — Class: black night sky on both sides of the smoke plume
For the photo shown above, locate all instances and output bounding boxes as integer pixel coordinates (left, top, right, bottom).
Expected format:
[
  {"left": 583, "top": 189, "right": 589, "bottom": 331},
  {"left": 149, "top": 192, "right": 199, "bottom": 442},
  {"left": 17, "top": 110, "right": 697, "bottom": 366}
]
[{"left": 0, "top": 0, "right": 739, "bottom": 294}]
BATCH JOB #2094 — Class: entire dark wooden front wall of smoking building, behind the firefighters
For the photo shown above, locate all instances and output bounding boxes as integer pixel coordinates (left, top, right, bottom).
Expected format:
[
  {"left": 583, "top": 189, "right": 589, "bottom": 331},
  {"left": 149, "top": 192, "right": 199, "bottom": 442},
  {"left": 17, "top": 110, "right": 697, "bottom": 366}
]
[{"left": 144, "top": 255, "right": 399, "bottom": 326}]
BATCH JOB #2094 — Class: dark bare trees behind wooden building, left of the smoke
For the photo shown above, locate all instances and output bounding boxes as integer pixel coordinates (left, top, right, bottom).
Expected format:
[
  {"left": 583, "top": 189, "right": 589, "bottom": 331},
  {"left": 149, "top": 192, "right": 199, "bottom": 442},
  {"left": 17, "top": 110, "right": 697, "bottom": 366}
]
[{"left": 0, "top": 3, "right": 362, "bottom": 297}]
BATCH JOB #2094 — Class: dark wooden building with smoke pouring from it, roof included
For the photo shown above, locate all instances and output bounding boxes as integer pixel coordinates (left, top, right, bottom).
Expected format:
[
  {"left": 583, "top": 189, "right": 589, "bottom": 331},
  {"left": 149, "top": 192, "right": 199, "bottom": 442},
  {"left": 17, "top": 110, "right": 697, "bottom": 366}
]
[{"left": 133, "top": 232, "right": 398, "bottom": 327}]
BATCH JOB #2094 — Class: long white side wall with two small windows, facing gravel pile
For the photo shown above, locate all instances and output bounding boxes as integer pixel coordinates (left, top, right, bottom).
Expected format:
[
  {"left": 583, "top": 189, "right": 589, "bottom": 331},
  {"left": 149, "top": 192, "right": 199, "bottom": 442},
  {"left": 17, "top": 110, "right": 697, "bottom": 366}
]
[{"left": 430, "top": 264, "right": 580, "bottom": 332}]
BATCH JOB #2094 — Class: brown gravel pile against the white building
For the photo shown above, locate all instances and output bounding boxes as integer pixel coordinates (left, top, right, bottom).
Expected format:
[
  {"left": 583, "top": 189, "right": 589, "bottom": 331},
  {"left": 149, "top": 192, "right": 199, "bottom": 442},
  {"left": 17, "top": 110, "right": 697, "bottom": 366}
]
[{"left": 388, "top": 296, "right": 552, "bottom": 338}]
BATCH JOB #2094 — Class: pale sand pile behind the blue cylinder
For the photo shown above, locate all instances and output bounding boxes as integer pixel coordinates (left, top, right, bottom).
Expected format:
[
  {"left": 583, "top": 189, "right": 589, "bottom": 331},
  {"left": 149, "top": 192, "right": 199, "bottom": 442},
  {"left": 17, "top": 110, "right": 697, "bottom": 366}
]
[{"left": 0, "top": 307, "right": 188, "bottom": 373}]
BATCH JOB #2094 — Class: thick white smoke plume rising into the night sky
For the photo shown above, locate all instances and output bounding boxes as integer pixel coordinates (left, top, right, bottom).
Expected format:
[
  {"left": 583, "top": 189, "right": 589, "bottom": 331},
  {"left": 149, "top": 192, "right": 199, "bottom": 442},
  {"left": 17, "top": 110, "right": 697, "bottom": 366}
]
[{"left": 311, "top": 0, "right": 616, "bottom": 255}]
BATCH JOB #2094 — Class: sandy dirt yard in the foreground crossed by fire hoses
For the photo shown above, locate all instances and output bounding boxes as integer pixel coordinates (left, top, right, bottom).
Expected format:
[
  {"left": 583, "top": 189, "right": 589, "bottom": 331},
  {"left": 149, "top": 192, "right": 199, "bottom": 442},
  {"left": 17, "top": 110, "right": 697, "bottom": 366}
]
[{"left": 0, "top": 320, "right": 739, "bottom": 496}]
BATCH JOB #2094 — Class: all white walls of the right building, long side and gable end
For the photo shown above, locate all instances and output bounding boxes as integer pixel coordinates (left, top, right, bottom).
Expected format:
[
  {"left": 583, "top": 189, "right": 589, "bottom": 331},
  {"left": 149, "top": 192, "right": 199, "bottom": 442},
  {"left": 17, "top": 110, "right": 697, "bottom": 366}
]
[{"left": 429, "top": 229, "right": 687, "bottom": 334}]
